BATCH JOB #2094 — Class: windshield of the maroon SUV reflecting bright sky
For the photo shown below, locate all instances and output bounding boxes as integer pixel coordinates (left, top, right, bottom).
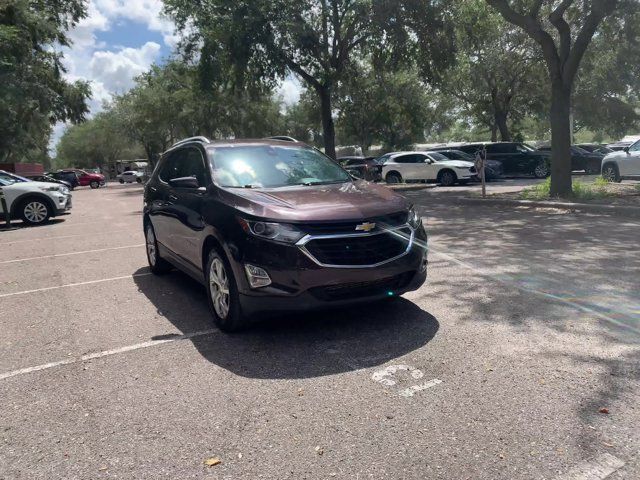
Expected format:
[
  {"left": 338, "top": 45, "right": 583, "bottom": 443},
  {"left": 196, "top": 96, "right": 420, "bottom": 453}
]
[{"left": 212, "top": 145, "right": 351, "bottom": 188}]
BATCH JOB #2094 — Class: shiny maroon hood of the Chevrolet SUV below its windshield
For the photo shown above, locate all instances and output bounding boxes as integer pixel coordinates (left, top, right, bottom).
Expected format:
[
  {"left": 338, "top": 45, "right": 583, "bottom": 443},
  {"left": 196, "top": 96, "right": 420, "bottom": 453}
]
[{"left": 220, "top": 181, "right": 411, "bottom": 222}]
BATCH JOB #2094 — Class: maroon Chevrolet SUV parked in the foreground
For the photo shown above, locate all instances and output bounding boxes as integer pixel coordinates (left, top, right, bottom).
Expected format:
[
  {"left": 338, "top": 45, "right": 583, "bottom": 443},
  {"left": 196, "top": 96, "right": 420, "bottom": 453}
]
[{"left": 144, "top": 137, "right": 427, "bottom": 331}]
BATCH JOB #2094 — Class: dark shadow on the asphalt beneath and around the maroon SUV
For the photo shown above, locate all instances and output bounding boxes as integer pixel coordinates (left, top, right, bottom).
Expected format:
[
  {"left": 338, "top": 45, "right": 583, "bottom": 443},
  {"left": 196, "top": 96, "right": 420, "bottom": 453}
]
[{"left": 134, "top": 271, "right": 439, "bottom": 379}]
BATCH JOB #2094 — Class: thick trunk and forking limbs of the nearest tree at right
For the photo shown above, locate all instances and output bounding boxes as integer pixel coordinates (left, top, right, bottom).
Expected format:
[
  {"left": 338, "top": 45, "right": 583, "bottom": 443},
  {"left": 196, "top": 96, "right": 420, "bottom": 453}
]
[{"left": 487, "top": 0, "right": 618, "bottom": 196}]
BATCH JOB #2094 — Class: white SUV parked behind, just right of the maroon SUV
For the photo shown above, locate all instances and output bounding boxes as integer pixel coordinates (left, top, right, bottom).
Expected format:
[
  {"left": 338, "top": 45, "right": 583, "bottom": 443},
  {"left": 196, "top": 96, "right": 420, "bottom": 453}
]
[{"left": 382, "top": 152, "right": 476, "bottom": 187}]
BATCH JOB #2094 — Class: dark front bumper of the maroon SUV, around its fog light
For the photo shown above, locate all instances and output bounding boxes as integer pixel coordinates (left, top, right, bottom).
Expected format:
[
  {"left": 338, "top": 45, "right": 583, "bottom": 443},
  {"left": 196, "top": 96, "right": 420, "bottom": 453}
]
[{"left": 232, "top": 227, "right": 427, "bottom": 317}]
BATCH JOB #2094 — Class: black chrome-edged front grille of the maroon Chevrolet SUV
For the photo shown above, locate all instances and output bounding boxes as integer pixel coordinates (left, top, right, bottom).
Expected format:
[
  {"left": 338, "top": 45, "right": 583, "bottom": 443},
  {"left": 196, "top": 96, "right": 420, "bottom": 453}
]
[{"left": 304, "top": 228, "right": 411, "bottom": 267}]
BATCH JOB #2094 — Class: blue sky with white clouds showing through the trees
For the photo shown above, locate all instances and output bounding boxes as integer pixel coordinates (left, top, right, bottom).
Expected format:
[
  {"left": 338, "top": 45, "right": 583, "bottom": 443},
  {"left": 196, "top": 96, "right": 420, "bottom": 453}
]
[{"left": 51, "top": 0, "right": 301, "bottom": 153}]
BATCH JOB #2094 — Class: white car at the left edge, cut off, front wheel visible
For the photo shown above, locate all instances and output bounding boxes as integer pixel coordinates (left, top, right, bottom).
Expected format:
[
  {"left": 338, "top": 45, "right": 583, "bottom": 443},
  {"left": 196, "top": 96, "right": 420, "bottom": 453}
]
[{"left": 0, "top": 170, "right": 71, "bottom": 225}]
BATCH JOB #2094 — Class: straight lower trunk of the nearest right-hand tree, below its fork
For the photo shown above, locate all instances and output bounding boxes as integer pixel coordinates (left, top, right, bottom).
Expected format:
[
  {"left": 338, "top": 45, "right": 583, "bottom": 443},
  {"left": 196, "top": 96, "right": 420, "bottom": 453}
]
[{"left": 550, "top": 79, "right": 573, "bottom": 197}]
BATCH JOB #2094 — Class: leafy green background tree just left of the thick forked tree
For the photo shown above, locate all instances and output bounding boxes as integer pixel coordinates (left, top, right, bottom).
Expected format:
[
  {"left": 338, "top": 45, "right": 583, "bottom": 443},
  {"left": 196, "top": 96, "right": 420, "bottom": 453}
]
[{"left": 440, "top": 0, "right": 544, "bottom": 141}]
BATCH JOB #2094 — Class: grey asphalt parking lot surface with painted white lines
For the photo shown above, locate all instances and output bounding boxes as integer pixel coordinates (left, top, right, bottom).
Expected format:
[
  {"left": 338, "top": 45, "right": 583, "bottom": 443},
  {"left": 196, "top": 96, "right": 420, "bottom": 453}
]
[{"left": 0, "top": 185, "right": 640, "bottom": 479}]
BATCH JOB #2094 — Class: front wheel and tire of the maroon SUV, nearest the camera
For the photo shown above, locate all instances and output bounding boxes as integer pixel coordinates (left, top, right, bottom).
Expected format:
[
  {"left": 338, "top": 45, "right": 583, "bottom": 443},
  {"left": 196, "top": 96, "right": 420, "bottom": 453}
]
[{"left": 205, "top": 248, "right": 247, "bottom": 333}]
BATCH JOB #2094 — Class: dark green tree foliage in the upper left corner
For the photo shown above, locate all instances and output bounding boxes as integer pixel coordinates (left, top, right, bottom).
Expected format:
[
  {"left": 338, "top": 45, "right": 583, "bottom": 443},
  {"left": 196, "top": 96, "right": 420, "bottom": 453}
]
[{"left": 0, "top": 0, "right": 90, "bottom": 162}]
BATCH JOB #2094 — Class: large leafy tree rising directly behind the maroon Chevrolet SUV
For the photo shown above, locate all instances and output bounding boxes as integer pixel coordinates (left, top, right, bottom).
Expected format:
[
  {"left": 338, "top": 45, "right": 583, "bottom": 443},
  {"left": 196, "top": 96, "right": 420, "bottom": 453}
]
[{"left": 165, "top": 0, "right": 452, "bottom": 157}]
